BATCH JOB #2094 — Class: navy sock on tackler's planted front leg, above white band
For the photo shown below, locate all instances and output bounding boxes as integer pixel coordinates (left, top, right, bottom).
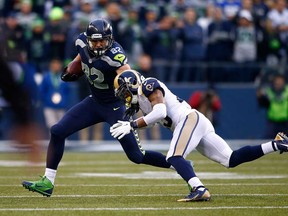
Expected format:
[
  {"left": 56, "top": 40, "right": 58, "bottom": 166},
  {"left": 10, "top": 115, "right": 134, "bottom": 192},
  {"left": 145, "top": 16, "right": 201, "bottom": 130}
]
[{"left": 168, "top": 156, "right": 196, "bottom": 182}]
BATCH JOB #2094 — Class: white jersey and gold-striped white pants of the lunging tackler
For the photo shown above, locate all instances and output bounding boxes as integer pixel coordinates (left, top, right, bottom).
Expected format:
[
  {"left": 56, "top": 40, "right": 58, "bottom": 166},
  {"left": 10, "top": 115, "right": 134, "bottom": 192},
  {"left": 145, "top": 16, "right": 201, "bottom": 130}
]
[{"left": 138, "top": 78, "right": 233, "bottom": 167}]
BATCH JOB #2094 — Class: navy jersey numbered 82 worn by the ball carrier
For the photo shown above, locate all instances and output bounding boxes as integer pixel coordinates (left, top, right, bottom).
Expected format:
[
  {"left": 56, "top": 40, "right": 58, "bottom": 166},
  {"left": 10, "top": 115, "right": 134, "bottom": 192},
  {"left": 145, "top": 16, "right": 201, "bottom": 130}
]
[{"left": 75, "top": 33, "right": 127, "bottom": 103}]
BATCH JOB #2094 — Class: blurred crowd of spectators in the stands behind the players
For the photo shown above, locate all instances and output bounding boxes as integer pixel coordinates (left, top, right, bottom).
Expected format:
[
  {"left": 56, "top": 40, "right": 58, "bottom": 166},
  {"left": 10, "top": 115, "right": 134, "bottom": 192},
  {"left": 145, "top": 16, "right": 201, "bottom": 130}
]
[{"left": 0, "top": 0, "right": 288, "bottom": 141}]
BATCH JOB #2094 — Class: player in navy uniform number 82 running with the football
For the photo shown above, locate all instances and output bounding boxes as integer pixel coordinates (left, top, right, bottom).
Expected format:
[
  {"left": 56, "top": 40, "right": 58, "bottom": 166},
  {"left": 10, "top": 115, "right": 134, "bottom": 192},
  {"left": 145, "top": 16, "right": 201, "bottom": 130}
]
[{"left": 22, "top": 19, "right": 171, "bottom": 196}]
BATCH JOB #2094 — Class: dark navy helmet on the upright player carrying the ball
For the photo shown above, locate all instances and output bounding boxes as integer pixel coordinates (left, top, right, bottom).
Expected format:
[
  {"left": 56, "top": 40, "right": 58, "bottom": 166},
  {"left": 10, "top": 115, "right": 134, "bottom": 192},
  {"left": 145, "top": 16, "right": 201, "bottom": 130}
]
[{"left": 84, "top": 19, "right": 113, "bottom": 57}]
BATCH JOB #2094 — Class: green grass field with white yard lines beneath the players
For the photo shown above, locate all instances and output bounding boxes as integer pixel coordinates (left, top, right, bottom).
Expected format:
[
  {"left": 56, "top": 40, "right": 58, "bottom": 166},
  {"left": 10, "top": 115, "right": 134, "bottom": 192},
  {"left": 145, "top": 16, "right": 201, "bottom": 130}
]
[{"left": 0, "top": 152, "right": 288, "bottom": 216}]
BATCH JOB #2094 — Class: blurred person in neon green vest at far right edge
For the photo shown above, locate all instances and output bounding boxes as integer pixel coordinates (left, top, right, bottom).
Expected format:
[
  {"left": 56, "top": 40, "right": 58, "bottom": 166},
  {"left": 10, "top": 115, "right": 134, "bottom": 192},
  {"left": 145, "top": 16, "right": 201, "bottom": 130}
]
[{"left": 257, "top": 74, "right": 288, "bottom": 139}]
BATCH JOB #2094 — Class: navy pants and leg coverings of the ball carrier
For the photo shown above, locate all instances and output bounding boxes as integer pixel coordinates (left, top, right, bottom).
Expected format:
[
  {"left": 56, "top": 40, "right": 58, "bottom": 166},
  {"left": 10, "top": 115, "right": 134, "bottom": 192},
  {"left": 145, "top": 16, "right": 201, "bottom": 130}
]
[{"left": 46, "top": 97, "right": 171, "bottom": 170}]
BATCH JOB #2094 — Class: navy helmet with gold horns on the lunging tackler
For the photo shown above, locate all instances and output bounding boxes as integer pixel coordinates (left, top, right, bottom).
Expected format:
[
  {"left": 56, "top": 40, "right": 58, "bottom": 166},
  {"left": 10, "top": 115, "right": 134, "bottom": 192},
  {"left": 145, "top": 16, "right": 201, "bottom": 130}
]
[{"left": 114, "top": 70, "right": 141, "bottom": 106}]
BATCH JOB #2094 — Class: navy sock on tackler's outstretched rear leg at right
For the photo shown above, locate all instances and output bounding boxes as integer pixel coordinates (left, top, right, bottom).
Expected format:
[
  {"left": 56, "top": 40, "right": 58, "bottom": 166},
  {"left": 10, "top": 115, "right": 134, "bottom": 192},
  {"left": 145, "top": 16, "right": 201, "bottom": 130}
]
[{"left": 229, "top": 145, "right": 264, "bottom": 167}]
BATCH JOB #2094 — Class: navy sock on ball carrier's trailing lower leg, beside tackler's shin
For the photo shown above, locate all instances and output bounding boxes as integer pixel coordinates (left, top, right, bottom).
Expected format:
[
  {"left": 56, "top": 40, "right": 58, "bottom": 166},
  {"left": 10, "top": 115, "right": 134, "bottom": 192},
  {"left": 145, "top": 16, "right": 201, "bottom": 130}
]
[{"left": 142, "top": 151, "right": 171, "bottom": 168}]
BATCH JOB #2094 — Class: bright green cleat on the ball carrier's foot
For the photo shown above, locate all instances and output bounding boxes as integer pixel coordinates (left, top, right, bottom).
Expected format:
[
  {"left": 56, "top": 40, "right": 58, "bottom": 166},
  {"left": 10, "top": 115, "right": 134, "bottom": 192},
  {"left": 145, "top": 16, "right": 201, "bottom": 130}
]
[{"left": 22, "top": 176, "right": 54, "bottom": 197}]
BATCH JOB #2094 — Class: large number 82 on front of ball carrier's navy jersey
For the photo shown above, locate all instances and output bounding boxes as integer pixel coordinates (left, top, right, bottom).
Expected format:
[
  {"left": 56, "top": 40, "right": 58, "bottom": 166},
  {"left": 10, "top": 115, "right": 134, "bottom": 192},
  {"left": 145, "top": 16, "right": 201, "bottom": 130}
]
[{"left": 84, "top": 64, "right": 109, "bottom": 89}]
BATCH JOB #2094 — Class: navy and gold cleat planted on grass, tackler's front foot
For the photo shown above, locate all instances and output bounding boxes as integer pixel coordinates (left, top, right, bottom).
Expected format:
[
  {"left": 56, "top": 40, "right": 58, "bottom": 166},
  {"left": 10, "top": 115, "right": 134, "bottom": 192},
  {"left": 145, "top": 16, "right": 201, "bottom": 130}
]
[{"left": 177, "top": 186, "right": 211, "bottom": 202}]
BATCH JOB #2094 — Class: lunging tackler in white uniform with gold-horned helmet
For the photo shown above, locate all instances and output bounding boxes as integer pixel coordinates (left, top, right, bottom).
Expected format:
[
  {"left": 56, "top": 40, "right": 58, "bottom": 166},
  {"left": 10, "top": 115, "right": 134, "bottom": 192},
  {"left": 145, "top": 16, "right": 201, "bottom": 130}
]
[{"left": 110, "top": 69, "right": 288, "bottom": 202}]
